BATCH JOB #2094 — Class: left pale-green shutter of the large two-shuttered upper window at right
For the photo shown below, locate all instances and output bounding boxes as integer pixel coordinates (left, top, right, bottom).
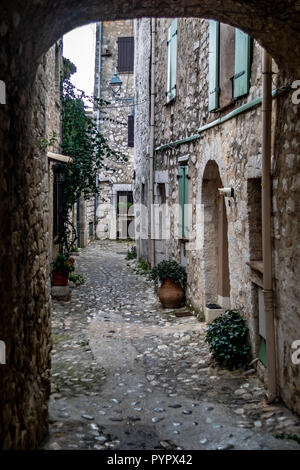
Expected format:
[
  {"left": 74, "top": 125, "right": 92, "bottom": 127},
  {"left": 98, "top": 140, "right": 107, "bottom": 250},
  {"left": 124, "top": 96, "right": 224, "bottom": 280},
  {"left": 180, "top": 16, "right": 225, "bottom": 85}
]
[{"left": 208, "top": 20, "right": 220, "bottom": 111}]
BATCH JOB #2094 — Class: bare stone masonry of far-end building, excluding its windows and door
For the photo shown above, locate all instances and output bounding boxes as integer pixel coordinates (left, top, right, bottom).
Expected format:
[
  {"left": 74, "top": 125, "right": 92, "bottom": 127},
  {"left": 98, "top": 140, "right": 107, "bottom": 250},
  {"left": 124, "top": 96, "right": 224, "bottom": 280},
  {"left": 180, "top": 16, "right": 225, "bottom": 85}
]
[{"left": 94, "top": 20, "right": 136, "bottom": 239}]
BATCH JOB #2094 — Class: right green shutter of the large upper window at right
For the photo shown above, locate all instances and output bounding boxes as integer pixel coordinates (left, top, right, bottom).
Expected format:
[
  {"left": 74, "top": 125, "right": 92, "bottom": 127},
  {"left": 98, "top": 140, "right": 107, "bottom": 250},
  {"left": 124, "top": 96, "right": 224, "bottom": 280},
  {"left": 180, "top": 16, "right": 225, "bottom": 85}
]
[{"left": 234, "top": 28, "right": 251, "bottom": 98}]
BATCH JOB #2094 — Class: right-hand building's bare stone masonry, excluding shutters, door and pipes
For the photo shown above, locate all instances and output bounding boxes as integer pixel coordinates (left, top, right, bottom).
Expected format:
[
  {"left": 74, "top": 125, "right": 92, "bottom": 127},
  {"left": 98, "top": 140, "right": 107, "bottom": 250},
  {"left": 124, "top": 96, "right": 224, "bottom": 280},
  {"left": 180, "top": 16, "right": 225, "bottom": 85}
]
[{"left": 136, "top": 19, "right": 300, "bottom": 412}]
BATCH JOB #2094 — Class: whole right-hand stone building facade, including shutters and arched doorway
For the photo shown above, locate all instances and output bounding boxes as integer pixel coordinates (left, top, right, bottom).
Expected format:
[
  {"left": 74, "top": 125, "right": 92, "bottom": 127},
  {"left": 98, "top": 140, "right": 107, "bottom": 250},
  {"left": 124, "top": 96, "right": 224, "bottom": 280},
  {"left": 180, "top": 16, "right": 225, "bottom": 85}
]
[{"left": 135, "top": 18, "right": 300, "bottom": 412}]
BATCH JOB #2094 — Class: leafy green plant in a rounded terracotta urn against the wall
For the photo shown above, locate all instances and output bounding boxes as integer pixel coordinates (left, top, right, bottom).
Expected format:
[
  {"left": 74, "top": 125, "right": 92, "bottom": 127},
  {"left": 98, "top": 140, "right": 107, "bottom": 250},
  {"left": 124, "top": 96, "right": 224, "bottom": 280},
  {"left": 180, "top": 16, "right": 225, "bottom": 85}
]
[{"left": 151, "top": 260, "right": 186, "bottom": 308}]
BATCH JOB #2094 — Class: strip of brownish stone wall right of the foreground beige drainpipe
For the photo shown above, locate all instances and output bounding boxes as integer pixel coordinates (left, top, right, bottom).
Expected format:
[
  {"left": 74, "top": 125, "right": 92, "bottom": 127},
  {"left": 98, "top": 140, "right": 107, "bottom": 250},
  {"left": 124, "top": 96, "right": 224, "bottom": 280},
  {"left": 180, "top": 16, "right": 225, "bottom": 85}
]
[{"left": 273, "top": 86, "right": 300, "bottom": 413}]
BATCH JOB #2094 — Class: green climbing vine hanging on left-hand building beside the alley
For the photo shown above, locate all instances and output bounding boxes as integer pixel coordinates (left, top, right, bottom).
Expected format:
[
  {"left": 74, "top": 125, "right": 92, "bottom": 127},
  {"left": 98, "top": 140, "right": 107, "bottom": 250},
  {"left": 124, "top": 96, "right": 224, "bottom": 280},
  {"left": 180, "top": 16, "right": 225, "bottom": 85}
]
[{"left": 60, "top": 59, "right": 127, "bottom": 255}]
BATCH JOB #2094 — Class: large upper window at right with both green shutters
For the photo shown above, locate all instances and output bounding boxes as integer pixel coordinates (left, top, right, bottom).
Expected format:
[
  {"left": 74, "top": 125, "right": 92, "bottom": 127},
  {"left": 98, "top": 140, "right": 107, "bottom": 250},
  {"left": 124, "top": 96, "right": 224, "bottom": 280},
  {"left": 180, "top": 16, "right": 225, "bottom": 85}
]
[{"left": 209, "top": 20, "right": 251, "bottom": 111}]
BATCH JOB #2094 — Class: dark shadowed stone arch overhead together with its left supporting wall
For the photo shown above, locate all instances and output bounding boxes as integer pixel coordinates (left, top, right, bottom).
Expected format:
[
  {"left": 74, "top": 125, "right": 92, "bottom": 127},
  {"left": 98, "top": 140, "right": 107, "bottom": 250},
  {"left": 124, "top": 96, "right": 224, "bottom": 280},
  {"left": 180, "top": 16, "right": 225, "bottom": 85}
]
[{"left": 0, "top": 0, "right": 300, "bottom": 449}]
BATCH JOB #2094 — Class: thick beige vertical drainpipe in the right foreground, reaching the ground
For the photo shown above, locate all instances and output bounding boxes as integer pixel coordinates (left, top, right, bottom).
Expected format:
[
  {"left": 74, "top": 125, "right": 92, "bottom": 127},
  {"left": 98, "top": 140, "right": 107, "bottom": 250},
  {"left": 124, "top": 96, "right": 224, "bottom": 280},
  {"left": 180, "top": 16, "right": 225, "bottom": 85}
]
[{"left": 262, "top": 50, "right": 277, "bottom": 403}]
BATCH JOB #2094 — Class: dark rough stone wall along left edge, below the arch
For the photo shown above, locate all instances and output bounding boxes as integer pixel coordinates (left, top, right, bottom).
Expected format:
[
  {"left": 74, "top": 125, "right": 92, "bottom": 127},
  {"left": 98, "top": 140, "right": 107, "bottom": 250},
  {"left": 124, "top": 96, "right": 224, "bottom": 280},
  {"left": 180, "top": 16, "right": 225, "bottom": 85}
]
[{"left": 0, "top": 51, "right": 51, "bottom": 449}]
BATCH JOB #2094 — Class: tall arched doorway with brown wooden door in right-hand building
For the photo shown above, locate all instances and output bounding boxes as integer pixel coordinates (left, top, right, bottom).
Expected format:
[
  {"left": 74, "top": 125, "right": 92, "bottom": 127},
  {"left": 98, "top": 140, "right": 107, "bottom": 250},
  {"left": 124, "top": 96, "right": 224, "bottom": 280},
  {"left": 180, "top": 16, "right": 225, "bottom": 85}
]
[{"left": 202, "top": 160, "right": 230, "bottom": 308}]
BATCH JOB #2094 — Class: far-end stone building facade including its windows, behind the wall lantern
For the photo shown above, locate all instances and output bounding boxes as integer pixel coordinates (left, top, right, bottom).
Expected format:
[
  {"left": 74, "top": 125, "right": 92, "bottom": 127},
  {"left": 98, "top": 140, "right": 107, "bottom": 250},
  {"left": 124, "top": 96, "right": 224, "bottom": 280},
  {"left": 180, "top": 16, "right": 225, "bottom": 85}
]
[{"left": 94, "top": 20, "right": 135, "bottom": 239}]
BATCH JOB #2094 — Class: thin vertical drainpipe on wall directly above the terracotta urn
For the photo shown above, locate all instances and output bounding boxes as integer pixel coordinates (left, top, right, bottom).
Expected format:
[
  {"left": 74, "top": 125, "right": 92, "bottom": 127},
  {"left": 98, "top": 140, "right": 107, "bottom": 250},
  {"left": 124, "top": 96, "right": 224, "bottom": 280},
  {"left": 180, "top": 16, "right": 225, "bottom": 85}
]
[{"left": 149, "top": 18, "right": 156, "bottom": 268}]
